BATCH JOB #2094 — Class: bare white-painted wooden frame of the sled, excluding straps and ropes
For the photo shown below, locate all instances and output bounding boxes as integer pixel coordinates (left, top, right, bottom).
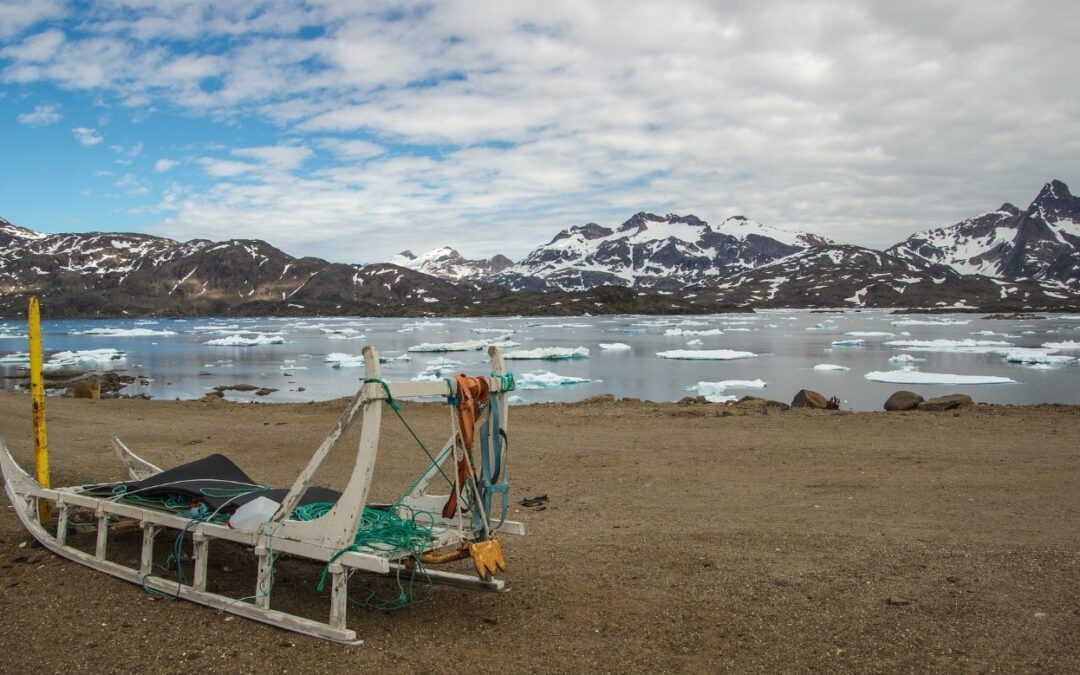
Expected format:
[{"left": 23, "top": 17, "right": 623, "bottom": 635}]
[{"left": 0, "top": 347, "right": 525, "bottom": 644}]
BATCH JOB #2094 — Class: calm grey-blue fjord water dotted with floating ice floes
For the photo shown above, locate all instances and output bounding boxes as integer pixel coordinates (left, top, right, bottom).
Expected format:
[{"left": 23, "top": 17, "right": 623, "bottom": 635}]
[{"left": 0, "top": 310, "right": 1080, "bottom": 410}]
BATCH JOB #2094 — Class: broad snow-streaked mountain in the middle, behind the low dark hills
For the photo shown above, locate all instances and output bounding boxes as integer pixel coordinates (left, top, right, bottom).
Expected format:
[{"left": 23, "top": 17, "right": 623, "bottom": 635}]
[{"left": 496, "top": 213, "right": 828, "bottom": 291}]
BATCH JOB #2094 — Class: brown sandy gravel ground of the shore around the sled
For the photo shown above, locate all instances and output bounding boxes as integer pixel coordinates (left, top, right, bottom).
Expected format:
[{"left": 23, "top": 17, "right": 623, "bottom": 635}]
[{"left": 0, "top": 393, "right": 1080, "bottom": 672}]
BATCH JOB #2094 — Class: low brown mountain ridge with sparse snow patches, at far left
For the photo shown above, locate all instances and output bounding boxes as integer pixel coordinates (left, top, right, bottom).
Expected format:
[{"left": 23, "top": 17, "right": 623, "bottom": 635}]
[{"left": 0, "top": 220, "right": 491, "bottom": 316}]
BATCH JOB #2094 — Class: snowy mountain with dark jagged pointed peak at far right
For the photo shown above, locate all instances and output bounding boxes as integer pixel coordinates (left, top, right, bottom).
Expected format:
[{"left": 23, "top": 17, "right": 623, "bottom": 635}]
[{"left": 888, "top": 180, "right": 1080, "bottom": 289}]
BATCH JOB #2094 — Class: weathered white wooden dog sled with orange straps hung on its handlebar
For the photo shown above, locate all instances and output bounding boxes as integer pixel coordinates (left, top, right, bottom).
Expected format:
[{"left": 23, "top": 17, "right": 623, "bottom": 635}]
[{"left": 0, "top": 347, "right": 524, "bottom": 644}]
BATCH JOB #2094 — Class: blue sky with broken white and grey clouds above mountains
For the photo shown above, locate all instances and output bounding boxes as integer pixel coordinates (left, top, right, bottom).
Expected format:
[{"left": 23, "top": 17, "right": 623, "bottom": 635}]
[{"left": 0, "top": 0, "right": 1080, "bottom": 262}]
